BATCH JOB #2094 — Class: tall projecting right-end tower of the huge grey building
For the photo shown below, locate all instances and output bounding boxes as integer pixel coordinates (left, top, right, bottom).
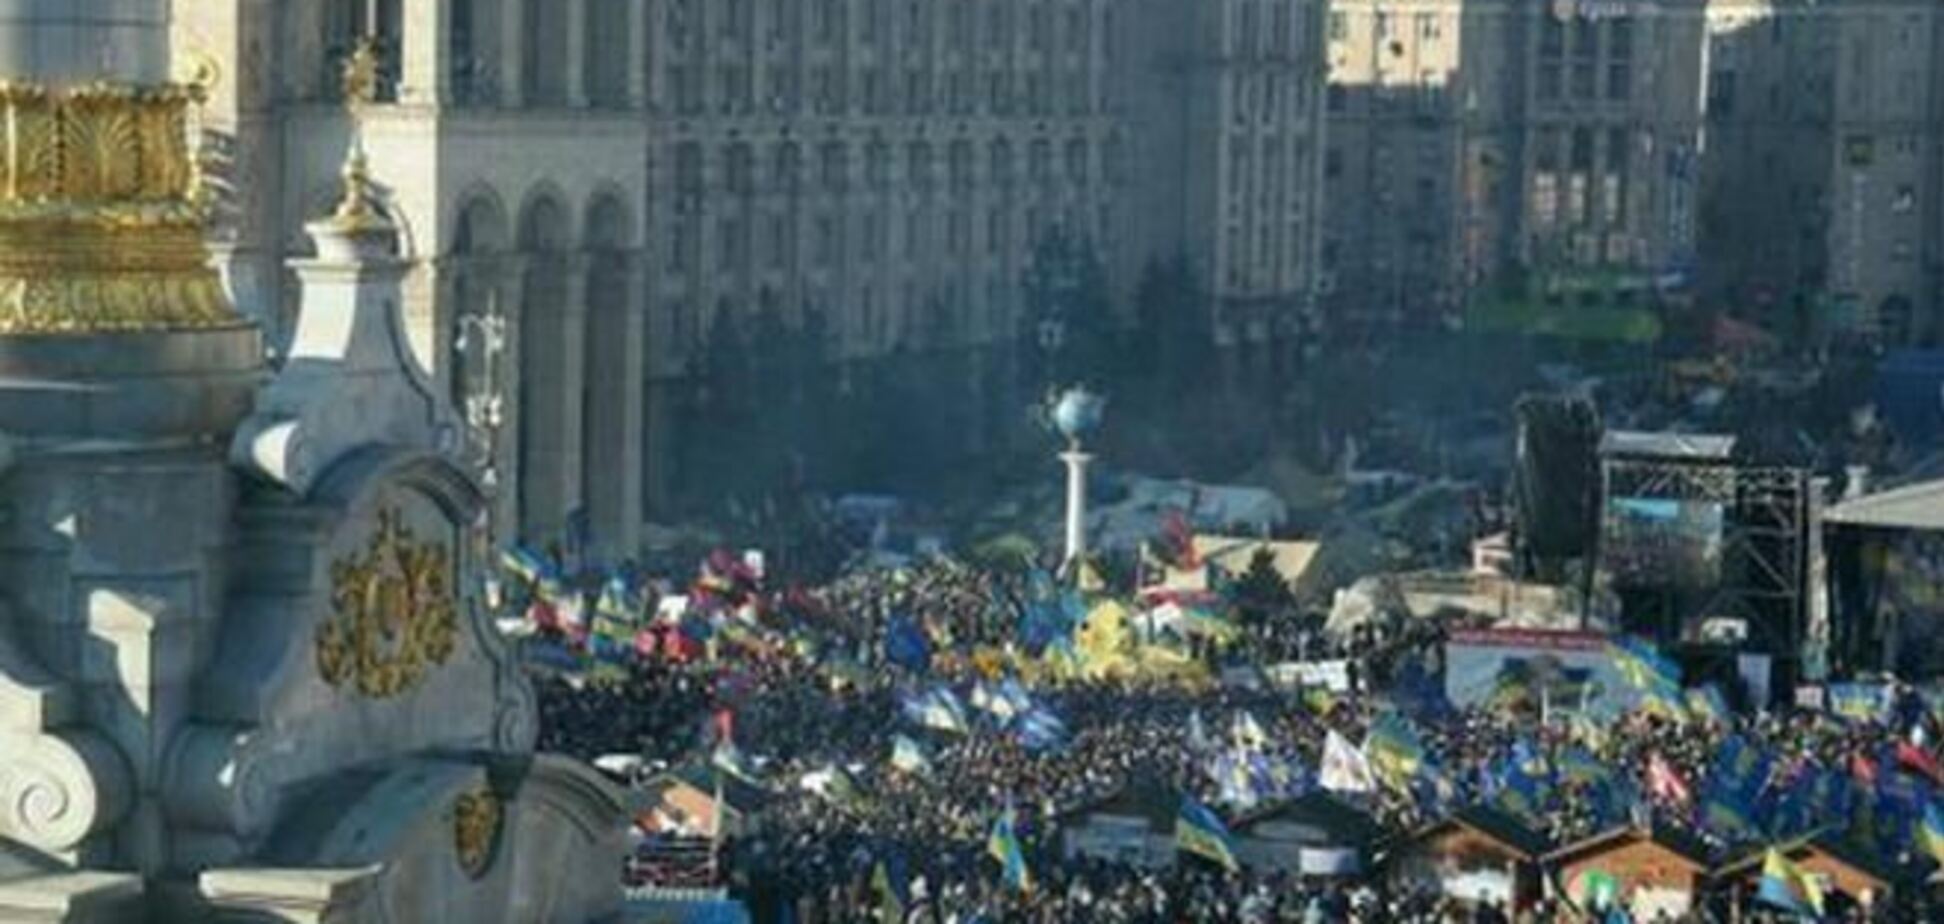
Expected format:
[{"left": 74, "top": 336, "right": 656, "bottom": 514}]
[{"left": 1128, "top": 0, "right": 1328, "bottom": 364}]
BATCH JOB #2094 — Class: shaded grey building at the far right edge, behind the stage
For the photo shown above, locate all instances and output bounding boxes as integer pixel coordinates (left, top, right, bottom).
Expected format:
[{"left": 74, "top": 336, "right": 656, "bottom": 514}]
[{"left": 1703, "top": 0, "right": 1944, "bottom": 344}]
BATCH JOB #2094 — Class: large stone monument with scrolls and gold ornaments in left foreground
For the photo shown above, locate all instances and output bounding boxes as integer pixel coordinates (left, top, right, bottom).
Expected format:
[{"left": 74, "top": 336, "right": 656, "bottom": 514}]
[{"left": 0, "top": 0, "right": 624, "bottom": 922}]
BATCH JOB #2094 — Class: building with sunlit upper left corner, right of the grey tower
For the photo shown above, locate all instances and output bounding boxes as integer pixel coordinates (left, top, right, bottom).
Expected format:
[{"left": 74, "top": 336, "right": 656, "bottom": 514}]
[{"left": 1324, "top": 0, "right": 1701, "bottom": 327}]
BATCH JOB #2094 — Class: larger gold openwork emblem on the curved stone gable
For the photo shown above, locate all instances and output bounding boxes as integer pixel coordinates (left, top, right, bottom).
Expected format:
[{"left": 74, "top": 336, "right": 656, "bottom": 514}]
[{"left": 317, "top": 510, "right": 459, "bottom": 698}]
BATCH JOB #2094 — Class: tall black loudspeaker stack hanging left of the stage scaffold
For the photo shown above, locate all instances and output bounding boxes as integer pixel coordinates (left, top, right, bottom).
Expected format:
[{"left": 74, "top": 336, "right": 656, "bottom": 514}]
[{"left": 1512, "top": 395, "right": 1600, "bottom": 558}]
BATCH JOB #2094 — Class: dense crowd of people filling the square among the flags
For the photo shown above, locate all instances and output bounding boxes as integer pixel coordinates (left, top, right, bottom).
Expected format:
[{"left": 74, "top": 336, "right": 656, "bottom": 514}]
[{"left": 513, "top": 560, "right": 1944, "bottom": 922}]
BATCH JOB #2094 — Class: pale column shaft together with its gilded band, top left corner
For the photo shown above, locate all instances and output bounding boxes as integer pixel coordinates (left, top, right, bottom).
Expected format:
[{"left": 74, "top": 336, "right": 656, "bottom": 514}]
[{"left": 0, "top": 0, "right": 239, "bottom": 335}]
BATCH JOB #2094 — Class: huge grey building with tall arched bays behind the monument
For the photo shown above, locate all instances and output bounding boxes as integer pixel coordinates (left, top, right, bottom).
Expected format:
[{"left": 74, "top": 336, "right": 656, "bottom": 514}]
[{"left": 177, "top": 0, "right": 1322, "bottom": 549}]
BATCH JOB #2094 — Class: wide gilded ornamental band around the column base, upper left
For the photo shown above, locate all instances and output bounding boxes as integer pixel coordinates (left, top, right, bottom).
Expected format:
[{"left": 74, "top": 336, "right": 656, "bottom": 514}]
[{"left": 0, "top": 82, "right": 237, "bottom": 335}]
